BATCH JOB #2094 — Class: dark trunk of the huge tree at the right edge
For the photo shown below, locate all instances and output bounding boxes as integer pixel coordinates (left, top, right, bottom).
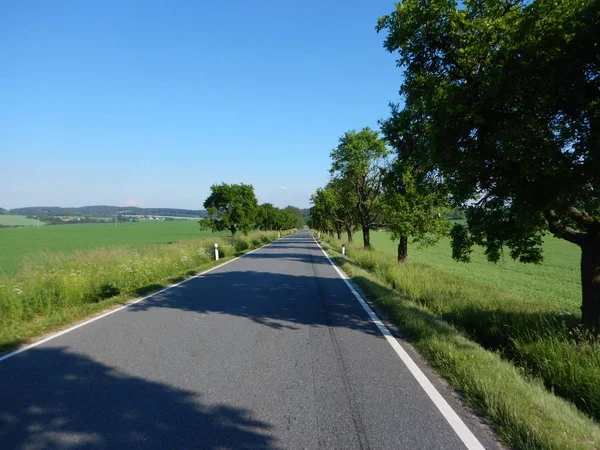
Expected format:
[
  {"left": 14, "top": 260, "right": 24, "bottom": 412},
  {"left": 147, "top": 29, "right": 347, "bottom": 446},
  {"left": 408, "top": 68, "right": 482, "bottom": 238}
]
[{"left": 581, "top": 239, "right": 600, "bottom": 333}]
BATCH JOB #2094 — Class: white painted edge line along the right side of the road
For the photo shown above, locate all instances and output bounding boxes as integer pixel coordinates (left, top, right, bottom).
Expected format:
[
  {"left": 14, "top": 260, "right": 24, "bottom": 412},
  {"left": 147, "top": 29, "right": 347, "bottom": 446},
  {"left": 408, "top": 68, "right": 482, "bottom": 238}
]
[{"left": 311, "top": 233, "right": 485, "bottom": 450}]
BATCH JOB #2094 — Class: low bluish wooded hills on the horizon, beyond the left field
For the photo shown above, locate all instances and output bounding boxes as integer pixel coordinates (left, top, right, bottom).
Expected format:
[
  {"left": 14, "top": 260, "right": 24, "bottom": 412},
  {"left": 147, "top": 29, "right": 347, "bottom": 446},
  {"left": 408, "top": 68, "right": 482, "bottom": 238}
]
[{"left": 6, "top": 205, "right": 207, "bottom": 217}]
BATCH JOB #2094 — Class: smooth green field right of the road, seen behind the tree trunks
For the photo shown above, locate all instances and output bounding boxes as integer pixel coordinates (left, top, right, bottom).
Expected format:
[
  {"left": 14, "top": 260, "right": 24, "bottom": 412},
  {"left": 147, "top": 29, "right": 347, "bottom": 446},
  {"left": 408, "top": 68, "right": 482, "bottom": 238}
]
[{"left": 366, "top": 231, "right": 581, "bottom": 314}]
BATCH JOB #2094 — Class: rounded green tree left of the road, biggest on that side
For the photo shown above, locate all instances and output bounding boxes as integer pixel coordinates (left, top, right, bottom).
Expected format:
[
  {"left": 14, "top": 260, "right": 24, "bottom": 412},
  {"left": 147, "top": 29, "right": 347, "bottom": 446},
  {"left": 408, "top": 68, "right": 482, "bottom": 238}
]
[{"left": 199, "top": 183, "right": 258, "bottom": 238}]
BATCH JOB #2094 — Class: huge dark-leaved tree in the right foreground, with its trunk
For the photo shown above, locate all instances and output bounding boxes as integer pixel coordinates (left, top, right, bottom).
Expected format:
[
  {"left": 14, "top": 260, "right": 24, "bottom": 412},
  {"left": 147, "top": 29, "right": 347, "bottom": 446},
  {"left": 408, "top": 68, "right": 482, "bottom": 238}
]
[{"left": 377, "top": 0, "right": 600, "bottom": 331}]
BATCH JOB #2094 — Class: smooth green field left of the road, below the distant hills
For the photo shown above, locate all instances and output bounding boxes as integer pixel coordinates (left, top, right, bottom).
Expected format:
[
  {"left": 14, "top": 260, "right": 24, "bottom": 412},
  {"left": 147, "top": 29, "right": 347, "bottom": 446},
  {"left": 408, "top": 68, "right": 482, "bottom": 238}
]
[{"left": 0, "top": 216, "right": 228, "bottom": 275}]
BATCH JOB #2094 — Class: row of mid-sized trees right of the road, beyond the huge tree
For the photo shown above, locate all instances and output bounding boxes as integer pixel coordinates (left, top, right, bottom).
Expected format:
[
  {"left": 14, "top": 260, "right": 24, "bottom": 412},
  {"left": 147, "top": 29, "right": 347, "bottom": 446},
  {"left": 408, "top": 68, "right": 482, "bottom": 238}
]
[{"left": 309, "top": 127, "right": 451, "bottom": 262}]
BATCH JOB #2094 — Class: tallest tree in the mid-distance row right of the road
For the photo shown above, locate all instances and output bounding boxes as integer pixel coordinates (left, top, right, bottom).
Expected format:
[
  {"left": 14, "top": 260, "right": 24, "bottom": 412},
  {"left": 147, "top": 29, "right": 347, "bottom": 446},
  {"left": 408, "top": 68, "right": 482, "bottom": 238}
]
[{"left": 330, "top": 127, "right": 389, "bottom": 248}]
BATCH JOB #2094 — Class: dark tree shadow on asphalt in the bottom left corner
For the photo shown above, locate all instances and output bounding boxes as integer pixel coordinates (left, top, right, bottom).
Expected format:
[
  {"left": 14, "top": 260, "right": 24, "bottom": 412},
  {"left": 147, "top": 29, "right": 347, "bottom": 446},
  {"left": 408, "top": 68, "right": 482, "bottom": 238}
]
[{"left": 0, "top": 348, "right": 276, "bottom": 449}]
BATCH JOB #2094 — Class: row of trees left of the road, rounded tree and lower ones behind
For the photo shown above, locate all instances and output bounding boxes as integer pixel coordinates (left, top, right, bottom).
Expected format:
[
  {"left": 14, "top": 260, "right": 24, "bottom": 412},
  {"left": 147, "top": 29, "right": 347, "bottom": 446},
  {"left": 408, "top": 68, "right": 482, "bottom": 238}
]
[{"left": 199, "top": 183, "right": 304, "bottom": 237}]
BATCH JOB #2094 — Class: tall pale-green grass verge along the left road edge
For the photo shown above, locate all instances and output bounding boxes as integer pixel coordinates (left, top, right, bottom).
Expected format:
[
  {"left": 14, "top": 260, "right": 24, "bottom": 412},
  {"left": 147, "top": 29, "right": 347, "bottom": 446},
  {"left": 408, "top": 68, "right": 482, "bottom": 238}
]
[{"left": 0, "top": 233, "right": 283, "bottom": 351}]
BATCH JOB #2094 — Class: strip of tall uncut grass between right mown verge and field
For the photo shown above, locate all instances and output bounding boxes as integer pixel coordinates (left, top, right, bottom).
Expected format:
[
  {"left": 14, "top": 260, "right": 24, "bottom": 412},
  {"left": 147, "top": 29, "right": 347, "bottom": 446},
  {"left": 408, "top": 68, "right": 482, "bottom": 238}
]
[{"left": 328, "top": 238, "right": 600, "bottom": 420}]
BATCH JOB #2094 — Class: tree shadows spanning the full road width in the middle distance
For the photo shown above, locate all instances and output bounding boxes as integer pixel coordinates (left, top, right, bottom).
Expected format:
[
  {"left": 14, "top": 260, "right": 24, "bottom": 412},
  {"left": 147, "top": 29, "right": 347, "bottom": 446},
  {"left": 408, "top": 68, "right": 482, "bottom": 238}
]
[{"left": 123, "top": 239, "right": 383, "bottom": 338}]
